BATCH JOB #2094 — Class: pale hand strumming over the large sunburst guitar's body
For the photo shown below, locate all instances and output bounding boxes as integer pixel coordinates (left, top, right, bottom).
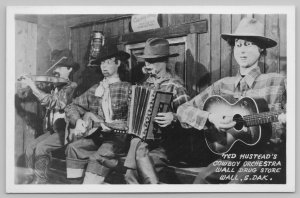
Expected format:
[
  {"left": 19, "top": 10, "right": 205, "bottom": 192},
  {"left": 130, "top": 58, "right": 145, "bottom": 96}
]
[{"left": 208, "top": 113, "right": 236, "bottom": 131}]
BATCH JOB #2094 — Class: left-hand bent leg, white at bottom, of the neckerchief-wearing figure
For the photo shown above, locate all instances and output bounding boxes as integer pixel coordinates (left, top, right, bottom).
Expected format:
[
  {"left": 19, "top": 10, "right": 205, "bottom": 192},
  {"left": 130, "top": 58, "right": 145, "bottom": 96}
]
[{"left": 66, "top": 138, "right": 98, "bottom": 179}]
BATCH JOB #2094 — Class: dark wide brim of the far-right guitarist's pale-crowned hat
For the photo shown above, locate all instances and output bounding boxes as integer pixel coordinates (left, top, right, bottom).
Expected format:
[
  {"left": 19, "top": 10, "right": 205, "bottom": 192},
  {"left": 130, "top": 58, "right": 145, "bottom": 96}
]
[{"left": 221, "top": 34, "right": 277, "bottom": 48}]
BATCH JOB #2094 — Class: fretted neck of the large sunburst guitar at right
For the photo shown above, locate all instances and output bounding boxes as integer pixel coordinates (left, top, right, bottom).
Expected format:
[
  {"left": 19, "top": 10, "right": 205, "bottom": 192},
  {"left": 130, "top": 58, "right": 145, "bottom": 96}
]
[{"left": 243, "top": 112, "right": 280, "bottom": 127}]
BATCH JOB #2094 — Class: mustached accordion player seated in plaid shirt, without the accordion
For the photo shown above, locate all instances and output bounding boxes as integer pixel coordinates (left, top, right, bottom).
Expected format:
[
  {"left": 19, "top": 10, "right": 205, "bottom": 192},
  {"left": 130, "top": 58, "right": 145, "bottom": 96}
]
[{"left": 124, "top": 38, "right": 189, "bottom": 184}]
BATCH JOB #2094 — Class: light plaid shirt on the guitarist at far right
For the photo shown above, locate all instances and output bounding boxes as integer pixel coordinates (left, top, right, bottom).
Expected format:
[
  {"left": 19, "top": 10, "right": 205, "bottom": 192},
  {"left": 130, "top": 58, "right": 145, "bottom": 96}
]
[{"left": 177, "top": 67, "right": 286, "bottom": 143}]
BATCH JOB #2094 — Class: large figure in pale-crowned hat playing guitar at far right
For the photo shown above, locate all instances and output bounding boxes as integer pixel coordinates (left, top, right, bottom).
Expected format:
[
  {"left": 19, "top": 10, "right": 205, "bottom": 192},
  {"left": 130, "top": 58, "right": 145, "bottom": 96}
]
[{"left": 177, "top": 17, "right": 286, "bottom": 184}]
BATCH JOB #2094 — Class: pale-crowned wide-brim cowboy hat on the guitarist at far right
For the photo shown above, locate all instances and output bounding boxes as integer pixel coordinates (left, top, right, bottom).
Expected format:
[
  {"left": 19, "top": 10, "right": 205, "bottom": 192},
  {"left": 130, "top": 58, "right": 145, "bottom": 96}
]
[{"left": 221, "top": 17, "right": 277, "bottom": 48}]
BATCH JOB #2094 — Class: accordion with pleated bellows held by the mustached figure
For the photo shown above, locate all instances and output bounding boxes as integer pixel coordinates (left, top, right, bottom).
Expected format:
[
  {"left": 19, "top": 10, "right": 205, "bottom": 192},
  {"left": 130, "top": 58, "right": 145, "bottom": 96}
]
[{"left": 128, "top": 85, "right": 173, "bottom": 140}]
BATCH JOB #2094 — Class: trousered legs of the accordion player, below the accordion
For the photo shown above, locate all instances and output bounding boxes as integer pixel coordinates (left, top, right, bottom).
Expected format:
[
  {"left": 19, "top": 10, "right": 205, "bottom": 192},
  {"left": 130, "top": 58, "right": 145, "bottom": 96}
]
[{"left": 125, "top": 129, "right": 184, "bottom": 184}]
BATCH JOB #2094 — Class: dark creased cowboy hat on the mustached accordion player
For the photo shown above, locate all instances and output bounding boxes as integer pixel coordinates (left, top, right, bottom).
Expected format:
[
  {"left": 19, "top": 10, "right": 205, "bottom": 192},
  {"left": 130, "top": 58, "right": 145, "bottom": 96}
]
[{"left": 137, "top": 38, "right": 179, "bottom": 59}]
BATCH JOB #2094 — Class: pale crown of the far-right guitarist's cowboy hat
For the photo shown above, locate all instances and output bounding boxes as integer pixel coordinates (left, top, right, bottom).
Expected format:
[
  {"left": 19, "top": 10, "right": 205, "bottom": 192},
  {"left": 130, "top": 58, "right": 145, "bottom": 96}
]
[{"left": 234, "top": 17, "right": 264, "bottom": 36}]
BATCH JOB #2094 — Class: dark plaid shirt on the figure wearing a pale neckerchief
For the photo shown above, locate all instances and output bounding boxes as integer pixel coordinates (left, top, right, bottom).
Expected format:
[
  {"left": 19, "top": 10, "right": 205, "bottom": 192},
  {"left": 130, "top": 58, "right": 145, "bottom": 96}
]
[{"left": 65, "top": 82, "right": 131, "bottom": 127}]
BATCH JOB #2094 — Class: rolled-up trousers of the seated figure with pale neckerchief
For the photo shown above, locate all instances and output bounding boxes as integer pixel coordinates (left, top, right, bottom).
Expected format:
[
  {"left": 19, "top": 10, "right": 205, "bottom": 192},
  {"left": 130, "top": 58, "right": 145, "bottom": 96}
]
[{"left": 66, "top": 130, "right": 129, "bottom": 178}]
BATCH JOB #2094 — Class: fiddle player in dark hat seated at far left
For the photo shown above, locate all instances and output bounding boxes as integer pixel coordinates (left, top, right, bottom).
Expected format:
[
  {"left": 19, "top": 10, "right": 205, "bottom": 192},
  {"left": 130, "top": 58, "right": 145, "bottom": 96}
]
[{"left": 20, "top": 49, "right": 79, "bottom": 184}]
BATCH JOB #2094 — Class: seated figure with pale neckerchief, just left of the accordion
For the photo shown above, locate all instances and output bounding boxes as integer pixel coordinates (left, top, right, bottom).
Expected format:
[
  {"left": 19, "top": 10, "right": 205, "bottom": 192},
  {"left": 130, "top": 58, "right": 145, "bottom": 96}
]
[{"left": 65, "top": 44, "right": 131, "bottom": 184}]
